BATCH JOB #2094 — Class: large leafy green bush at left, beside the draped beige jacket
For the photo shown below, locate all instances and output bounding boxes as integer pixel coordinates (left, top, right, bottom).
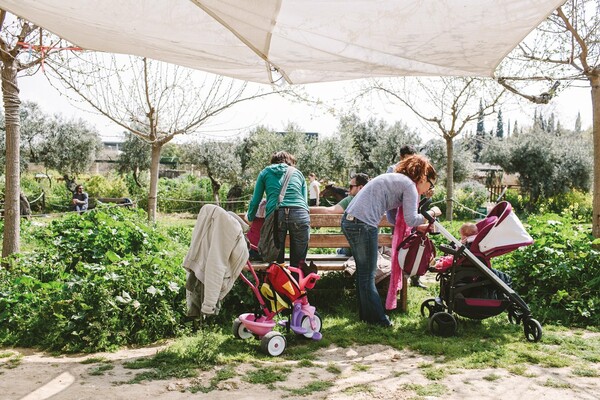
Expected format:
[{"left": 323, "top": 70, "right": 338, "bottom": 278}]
[{"left": 0, "top": 208, "right": 185, "bottom": 352}]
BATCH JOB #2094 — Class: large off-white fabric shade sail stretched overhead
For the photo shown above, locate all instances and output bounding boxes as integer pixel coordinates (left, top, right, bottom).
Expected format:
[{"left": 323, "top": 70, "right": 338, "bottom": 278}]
[{"left": 0, "top": 0, "right": 565, "bottom": 83}]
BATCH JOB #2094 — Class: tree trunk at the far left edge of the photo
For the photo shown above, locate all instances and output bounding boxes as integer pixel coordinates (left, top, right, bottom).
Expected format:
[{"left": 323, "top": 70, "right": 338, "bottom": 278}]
[{"left": 2, "top": 59, "right": 21, "bottom": 257}]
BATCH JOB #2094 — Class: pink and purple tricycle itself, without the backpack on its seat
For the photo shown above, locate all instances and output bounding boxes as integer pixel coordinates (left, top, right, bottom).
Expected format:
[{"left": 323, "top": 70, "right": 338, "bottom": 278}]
[{"left": 232, "top": 261, "right": 322, "bottom": 356}]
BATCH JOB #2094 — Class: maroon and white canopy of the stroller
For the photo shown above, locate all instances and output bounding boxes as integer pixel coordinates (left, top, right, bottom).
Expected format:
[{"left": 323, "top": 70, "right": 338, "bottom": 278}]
[{"left": 471, "top": 201, "right": 533, "bottom": 258}]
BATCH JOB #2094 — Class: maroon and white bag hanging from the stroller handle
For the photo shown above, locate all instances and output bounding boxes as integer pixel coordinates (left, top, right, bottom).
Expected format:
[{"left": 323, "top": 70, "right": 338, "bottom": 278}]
[{"left": 398, "top": 231, "right": 435, "bottom": 276}]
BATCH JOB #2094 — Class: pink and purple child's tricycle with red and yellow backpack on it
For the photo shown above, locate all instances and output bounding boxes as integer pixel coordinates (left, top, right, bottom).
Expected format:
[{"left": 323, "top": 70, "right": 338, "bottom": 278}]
[{"left": 233, "top": 261, "right": 322, "bottom": 356}]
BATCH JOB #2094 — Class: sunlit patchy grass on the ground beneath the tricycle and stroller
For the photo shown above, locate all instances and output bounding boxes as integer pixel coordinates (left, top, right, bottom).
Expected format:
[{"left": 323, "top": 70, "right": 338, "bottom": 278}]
[{"left": 109, "top": 287, "right": 600, "bottom": 396}]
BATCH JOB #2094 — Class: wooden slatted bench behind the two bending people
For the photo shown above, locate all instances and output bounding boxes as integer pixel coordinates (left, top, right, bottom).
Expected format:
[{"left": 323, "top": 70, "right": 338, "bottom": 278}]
[{"left": 240, "top": 214, "right": 408, "bottom": 311}]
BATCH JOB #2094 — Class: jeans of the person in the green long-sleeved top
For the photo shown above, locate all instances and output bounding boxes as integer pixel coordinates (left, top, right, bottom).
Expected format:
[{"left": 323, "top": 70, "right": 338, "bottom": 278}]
[{"left": 277, "top": 207, "right": 310, "bottom": 267}]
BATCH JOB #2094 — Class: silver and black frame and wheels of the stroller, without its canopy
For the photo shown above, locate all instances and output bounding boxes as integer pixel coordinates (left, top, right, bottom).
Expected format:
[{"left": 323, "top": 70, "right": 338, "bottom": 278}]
[{"left": 419, "top": 199, "right": 542, "bottom": 342}]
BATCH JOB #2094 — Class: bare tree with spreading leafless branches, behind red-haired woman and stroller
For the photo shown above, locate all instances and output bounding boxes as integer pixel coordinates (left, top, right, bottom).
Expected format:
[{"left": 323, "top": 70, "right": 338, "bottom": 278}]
[{"left": 368, "top": 77, "right": 505, "bottom": 220}]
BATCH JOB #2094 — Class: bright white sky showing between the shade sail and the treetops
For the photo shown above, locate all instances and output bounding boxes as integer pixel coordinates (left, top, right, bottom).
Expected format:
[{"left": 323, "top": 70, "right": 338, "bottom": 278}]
[{"left": 11, "top": 71, "right": 592, "bottom": 144}]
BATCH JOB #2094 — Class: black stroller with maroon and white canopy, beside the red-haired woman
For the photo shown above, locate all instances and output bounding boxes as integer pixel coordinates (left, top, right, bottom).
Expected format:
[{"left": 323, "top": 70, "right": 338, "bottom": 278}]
[{"left": 420, "top": 200, "right": 542, "bottom": 342}]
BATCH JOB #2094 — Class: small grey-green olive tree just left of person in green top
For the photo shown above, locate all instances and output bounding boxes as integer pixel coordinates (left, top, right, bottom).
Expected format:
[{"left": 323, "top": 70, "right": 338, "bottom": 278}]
[{"left": 183, "top": 140, "right": 242, "bottom": 204}]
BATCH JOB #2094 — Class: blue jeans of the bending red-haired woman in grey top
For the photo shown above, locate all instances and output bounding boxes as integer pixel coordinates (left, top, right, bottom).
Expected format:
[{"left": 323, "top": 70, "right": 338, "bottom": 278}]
[{"left": 342, "top": 214, "right": 390, "bottom": 325}]
